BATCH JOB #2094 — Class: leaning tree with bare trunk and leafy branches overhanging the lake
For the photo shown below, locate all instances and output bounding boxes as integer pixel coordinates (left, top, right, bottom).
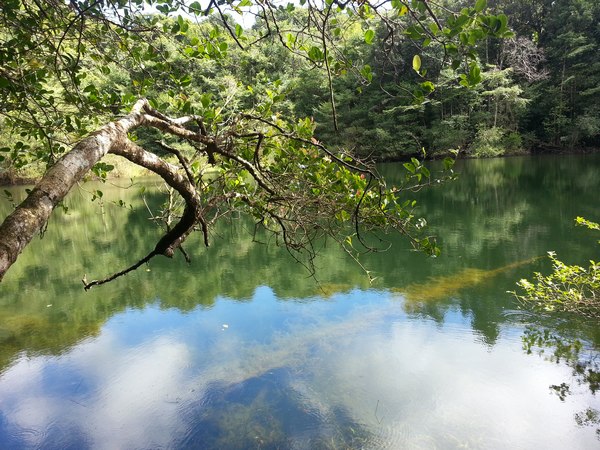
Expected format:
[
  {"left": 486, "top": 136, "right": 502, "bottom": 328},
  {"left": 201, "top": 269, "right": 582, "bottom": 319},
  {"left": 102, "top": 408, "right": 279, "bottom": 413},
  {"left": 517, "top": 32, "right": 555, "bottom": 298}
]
[{"left": 0, "top": 0, "right": 507, "bottom": 288}]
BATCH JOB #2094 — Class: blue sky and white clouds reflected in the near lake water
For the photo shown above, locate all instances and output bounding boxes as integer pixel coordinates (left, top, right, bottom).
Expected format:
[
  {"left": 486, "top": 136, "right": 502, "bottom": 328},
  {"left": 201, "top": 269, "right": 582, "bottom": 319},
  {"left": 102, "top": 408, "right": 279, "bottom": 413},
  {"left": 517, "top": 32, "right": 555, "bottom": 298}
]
[{"left": 0, "top": 287, "right": 598, "bottom": 449}]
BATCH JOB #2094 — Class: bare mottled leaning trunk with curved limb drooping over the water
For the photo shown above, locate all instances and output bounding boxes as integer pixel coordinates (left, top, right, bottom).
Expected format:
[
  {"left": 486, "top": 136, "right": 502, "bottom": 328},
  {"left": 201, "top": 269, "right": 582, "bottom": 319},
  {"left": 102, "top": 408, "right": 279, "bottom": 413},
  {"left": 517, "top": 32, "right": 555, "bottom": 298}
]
[{"left": 0, "top": 99, "right": 207, "bottom": 287}]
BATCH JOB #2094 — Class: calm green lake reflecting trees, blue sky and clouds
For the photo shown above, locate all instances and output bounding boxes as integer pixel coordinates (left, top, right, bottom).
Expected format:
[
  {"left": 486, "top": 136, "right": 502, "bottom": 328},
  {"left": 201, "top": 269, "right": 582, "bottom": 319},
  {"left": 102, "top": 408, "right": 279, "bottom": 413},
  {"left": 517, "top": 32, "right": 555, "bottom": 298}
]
[{"left": 0, "top": 155, "right": 600, "bottom": 449}]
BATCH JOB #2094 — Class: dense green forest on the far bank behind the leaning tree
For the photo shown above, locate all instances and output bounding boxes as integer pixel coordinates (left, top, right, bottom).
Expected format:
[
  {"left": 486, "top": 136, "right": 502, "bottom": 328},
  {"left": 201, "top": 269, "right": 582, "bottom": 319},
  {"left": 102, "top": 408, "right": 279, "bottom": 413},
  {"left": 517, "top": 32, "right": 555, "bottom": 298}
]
[{"left": 0, "top": 0, "right": 600, "bottom": 182}]
